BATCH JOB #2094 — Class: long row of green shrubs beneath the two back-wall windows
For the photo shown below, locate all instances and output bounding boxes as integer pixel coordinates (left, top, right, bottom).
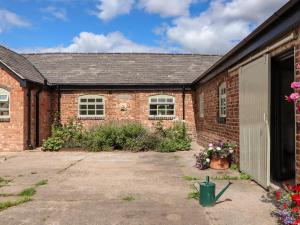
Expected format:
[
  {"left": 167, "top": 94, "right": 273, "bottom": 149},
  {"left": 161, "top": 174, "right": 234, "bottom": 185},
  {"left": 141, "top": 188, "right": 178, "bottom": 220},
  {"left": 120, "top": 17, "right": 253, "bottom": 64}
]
[{"left": 42, "top": 120, "right": 191, "bottom": 152}]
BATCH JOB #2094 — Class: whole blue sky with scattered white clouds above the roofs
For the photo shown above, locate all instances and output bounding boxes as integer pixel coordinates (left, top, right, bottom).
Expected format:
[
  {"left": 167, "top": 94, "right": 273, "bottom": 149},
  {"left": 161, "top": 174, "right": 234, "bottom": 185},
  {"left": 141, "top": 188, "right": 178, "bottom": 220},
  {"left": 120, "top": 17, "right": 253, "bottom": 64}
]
[{"left": 0, "top": 0, "right": 287, "bottom": 54}]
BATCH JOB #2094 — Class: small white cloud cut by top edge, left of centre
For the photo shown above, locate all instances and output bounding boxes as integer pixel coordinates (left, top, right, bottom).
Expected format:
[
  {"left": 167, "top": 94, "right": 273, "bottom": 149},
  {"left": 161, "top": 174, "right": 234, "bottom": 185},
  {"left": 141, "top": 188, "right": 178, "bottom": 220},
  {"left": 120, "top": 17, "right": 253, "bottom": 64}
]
[{"left": 93, "top": 0, "right": 134, "bottom": 20}]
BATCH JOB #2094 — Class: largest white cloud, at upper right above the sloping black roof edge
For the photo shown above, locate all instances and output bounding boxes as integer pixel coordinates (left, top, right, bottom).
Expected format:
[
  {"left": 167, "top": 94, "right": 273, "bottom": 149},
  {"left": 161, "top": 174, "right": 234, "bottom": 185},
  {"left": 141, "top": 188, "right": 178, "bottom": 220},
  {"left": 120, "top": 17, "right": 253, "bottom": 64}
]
[{"left": 165, "top": 0, "right": 287, "bottom": 54}]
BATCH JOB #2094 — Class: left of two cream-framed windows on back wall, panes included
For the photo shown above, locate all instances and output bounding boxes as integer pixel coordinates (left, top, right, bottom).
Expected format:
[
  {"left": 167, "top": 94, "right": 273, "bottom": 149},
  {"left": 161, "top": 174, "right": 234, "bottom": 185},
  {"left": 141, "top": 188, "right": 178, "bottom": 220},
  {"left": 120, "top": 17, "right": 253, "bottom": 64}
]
[{"left": 78, "top": 95, "right": 105, "bottom": 118}]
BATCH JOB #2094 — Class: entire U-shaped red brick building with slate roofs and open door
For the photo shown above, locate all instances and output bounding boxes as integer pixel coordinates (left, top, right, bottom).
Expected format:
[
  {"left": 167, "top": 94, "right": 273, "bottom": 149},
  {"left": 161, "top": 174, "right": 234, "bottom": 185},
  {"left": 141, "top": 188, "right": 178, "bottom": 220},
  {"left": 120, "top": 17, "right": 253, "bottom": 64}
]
[{"left": 0, "top": 0, "right": 300, "bottom": 187}]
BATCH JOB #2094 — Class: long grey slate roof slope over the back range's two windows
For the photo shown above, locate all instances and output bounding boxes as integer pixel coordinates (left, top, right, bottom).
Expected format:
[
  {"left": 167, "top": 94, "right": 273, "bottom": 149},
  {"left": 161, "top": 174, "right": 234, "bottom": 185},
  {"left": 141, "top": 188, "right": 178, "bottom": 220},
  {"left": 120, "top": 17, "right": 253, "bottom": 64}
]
[{"left": 23, "top": 53, "right": 220, "bottom": 85}]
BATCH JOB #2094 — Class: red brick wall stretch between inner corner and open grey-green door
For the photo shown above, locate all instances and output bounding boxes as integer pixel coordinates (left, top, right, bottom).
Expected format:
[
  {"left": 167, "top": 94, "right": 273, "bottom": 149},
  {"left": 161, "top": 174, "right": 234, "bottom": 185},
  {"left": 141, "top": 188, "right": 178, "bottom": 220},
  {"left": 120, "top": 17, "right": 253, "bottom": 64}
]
[{"left": 194, "top": 72, "right": 239, "bottom": 146}]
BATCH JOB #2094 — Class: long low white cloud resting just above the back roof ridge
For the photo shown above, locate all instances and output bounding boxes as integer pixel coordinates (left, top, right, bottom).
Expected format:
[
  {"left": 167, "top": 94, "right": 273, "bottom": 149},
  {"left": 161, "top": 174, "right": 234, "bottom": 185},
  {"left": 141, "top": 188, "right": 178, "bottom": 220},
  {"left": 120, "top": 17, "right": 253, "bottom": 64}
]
[{"left": 19, "top": 32, "right": 164, "bottom": 53}]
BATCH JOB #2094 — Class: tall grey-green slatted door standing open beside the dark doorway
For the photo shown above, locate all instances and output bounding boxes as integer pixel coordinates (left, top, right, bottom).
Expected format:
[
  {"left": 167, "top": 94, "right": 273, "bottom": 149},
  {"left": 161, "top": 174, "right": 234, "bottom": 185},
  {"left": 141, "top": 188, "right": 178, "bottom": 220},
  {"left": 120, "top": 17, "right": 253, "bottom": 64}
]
[{"left": 239, "top": 55, "right": 270, "bottom": 187}]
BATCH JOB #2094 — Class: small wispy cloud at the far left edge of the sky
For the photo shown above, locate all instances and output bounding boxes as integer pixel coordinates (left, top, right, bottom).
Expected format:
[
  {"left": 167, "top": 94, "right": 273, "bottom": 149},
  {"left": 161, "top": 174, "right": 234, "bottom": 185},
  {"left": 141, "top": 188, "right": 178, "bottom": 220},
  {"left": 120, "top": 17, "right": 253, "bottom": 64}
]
[{"left": 0, "top": 9, "right": 31, "bottom": 34}]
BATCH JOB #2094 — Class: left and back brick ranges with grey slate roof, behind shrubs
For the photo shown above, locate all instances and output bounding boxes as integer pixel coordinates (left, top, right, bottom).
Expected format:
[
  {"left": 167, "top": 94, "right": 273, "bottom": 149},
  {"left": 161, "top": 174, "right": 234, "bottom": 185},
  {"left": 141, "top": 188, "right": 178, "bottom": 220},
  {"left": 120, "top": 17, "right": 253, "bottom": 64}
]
[{"left": 0, "top": 47, "right": 220, "bottom": 151}]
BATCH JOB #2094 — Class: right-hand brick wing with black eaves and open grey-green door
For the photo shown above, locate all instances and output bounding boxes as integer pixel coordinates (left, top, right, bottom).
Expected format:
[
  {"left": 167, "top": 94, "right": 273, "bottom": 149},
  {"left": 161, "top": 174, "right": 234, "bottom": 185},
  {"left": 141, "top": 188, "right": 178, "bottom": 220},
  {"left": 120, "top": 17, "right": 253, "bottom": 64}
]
[{"left": 193, "top": 1, "right": 300, "bottom": 187}]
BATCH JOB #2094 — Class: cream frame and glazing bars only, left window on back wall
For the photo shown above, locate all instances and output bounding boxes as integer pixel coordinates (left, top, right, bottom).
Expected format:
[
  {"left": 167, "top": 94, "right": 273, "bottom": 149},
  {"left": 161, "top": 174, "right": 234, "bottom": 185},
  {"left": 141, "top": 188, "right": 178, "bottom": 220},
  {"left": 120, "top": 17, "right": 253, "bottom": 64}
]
[{"left": 77, "top": 95, "right": 105, "bottom": 119}]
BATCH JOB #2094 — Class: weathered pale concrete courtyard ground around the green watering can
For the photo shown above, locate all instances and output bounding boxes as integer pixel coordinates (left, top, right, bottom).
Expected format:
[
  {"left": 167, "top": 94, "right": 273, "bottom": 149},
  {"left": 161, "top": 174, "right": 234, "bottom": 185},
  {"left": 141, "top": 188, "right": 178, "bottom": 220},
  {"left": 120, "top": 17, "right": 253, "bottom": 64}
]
[{"left": 0, "top": 151, "right": 276, "bottom": 225}]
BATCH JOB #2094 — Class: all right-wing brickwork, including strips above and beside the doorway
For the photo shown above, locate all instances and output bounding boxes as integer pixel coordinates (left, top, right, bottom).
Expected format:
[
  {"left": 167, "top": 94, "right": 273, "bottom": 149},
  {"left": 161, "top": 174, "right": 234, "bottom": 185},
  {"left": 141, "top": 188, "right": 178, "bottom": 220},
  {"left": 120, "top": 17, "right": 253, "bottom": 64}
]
[{"left": 194, "top": 28, "right": 300, "bottom": 182}]
